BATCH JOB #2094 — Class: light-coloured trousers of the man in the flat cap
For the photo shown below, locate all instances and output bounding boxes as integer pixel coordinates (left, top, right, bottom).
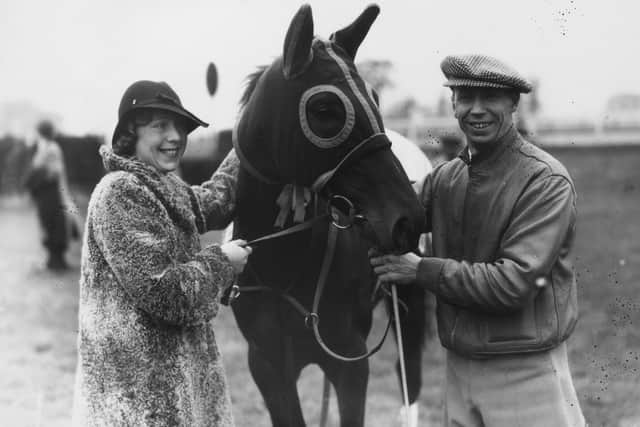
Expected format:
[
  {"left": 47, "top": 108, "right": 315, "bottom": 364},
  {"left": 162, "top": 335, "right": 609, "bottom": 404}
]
[{"left": 445, "top": 343, "right": 585, "bottom": 427}]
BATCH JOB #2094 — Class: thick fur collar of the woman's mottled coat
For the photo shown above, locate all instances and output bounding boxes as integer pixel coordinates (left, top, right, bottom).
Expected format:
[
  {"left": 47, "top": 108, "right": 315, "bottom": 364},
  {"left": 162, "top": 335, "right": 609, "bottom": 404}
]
[{"left": 100, "top": 145, "right": 206, "bottom": 233}]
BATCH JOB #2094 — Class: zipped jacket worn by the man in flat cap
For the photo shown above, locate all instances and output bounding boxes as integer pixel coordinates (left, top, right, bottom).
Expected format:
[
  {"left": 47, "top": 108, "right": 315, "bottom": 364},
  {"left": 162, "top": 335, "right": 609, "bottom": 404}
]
[{"left": 418, "top": 128, "right": 578, "bottom": 358}]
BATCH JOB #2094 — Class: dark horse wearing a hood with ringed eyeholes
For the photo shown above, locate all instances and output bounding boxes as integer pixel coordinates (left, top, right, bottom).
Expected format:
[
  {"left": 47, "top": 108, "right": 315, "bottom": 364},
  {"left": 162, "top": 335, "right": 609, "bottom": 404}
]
[{"left": 228, "top": 5, "right": 427, "bottom": 427}]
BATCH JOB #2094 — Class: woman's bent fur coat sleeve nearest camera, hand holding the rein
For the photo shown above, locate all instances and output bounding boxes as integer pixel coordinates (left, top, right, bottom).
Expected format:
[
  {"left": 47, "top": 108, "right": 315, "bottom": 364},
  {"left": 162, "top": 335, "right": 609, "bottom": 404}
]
[{"left": 90, "top": 178, "right": 234, "bottom": 326}]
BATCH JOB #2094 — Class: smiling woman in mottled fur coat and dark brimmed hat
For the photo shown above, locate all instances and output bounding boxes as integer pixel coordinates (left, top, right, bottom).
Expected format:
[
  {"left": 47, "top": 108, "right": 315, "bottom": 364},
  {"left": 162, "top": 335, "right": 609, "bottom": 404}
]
[{"left": 74, "top": 81, "right": 251, "bottom": 426}]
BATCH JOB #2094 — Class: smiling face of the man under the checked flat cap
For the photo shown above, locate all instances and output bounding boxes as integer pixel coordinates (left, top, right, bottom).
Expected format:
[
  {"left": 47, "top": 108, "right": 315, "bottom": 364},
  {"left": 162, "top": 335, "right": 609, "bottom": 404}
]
[{"left": 453, "top": 87, "right": 517, "bottom": 149}]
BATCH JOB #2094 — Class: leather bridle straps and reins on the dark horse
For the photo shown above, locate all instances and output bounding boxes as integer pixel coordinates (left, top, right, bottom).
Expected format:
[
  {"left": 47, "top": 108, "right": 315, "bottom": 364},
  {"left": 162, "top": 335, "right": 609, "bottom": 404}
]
[{"left": 228, "top": 132, "right": 392, "bottom": 362}]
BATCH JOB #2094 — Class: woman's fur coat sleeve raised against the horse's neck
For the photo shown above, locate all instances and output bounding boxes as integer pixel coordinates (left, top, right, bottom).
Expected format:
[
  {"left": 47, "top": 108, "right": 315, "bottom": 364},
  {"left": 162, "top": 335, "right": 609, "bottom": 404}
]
[{"left": 191, "top": 149, "right": 240, "bottom": 230}]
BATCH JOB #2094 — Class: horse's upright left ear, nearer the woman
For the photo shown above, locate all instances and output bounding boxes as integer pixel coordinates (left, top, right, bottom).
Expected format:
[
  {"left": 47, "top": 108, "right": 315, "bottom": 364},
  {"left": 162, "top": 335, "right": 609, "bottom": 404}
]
[{"left": 282, "top": 4, "right": 313, "bottom": 79}]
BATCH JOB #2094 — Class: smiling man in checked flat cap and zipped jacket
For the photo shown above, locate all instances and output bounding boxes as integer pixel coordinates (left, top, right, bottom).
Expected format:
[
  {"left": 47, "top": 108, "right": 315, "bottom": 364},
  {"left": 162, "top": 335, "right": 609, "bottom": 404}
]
[{"left": 371, "top": 55, "right": 585, "bottom": 427}]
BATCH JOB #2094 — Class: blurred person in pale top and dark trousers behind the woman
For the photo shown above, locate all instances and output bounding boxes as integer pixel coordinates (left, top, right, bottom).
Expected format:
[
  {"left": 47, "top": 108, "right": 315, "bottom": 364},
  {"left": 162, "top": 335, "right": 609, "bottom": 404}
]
[{"left": 25, "top": 120, "right": 79, "bottom": 271}]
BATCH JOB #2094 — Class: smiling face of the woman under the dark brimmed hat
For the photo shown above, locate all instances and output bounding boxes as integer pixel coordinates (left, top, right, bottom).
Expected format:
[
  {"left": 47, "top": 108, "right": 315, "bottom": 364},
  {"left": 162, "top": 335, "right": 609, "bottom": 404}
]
[{"left": 135, "top": 111, "right": 187, "bottom": 173}]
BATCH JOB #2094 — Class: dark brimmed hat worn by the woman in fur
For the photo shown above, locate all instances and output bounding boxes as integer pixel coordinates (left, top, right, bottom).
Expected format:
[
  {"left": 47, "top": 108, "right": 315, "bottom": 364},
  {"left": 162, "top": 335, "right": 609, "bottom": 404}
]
[{"left": 111, "top": 80, "right": 209, "bottom": 142}]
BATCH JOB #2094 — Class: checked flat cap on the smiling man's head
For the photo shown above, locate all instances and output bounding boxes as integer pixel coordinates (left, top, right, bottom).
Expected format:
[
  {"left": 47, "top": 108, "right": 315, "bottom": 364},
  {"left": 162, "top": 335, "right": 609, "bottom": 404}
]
[{"left": 440, "top": 55, "right": 532, "bottom": 93}]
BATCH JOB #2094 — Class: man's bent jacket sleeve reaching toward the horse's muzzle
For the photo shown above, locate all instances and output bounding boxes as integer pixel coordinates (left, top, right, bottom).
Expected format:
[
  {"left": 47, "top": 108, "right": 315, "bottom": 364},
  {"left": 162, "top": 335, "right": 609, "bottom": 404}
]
[{"left": 417, "top": 175, "right": 576, "bottom": 313}]
